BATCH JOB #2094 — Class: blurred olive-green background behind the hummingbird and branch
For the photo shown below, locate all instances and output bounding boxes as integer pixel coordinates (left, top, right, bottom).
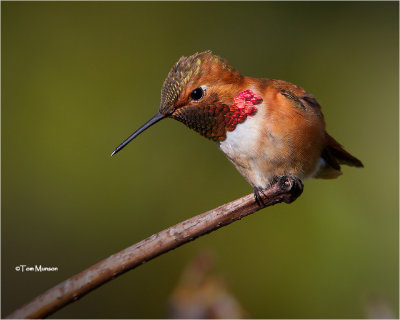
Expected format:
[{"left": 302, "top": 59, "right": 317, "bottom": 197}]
[{"left": 1, "top": 2, "right": 399, "bottom": 318}]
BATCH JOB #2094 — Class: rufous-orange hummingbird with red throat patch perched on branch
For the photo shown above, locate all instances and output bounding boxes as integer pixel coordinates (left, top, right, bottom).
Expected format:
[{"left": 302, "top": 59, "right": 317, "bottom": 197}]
[{"left": 111, "top": 51, "right": 363, "bottom": 205}]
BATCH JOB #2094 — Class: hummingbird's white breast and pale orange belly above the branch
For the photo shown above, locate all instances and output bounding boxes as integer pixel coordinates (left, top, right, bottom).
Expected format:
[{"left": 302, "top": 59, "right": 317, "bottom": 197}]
[{"left": 218, "top": 112, "right": 320, "bottom": 188}]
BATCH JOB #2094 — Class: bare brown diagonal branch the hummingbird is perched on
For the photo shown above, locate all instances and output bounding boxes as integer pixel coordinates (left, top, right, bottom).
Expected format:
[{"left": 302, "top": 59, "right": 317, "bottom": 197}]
[{"left": 7, "top": 177, "right": 303, "bottom": 319}]
